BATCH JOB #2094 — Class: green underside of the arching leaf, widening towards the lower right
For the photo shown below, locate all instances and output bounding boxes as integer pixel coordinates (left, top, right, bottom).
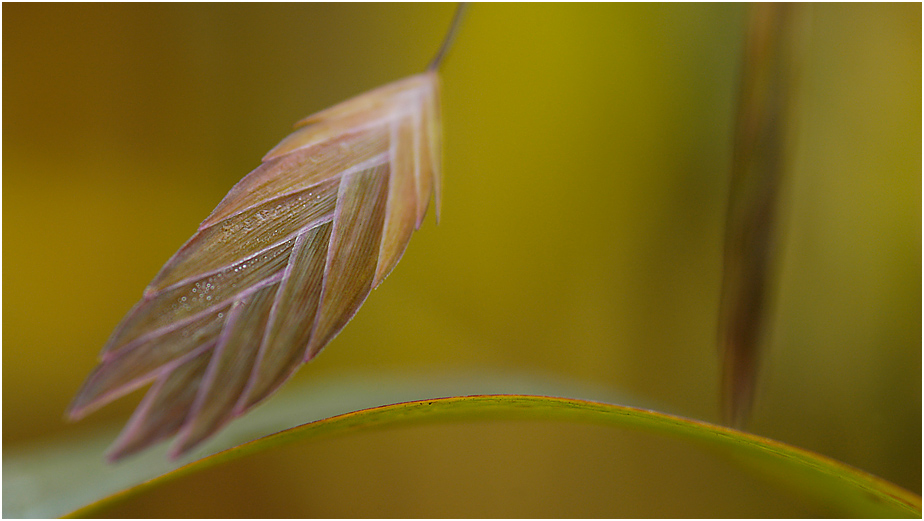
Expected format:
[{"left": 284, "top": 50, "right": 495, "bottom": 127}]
[{"left": 63, "top": 395, "right": 921, "bottom": 517}]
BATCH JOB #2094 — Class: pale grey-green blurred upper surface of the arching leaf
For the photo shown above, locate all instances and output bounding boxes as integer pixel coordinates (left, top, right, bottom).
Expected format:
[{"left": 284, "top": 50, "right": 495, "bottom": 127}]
[{"left": 2, "top": 370, "right": 653, "bottom": 518}]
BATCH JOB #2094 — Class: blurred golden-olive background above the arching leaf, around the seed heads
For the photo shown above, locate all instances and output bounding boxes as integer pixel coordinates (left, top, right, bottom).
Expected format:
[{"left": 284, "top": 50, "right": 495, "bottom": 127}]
[{"left": 2, "top": 4, "right": 921, "bottom": 508}]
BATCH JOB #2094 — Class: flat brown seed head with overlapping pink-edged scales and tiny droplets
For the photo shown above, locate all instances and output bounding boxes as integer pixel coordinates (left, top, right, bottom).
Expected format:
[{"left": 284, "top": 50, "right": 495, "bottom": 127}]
[{"left": 69, "top": 69, "right": 441, "bottom": 460}]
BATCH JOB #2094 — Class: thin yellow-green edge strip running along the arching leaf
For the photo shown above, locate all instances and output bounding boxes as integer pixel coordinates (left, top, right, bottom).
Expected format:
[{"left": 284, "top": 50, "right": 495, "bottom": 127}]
[{"left": 65, "top": 395, "right": 921, "bottom": 518}]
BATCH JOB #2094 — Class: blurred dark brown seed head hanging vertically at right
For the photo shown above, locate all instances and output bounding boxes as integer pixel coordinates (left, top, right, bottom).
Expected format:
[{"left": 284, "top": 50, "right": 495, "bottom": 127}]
[{"left": 719, "top": 4, "right": 808, "bottom": 427}]
